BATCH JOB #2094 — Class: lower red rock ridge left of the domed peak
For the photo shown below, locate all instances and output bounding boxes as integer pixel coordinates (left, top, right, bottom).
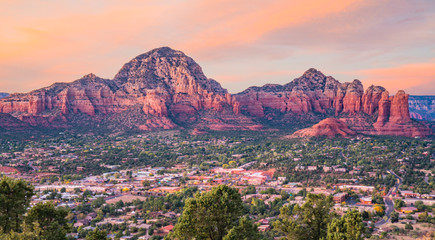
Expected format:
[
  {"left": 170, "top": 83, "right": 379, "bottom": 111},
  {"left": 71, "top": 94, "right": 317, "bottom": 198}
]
[{"left": 0, "top": 74, "right": 120, "bottom": 128}]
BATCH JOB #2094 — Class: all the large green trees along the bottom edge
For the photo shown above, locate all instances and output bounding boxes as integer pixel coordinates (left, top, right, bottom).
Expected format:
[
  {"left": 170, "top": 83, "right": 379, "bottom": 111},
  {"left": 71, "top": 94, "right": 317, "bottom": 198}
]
[{"left": 0, "top": 174, "right": 365, "bottom": 240}]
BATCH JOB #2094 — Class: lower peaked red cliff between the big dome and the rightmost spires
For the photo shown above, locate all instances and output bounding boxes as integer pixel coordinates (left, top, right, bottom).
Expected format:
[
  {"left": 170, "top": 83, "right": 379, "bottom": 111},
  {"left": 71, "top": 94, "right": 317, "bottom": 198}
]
[{"left": 235, "top": 68, "right": 370, "bottom": 117}]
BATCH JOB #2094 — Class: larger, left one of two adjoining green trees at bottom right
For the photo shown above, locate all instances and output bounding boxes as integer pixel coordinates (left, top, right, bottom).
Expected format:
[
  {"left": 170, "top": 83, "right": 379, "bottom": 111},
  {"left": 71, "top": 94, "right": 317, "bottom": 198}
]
[{"left": 275, "top": 193, "right": 334, "bottom": 240}]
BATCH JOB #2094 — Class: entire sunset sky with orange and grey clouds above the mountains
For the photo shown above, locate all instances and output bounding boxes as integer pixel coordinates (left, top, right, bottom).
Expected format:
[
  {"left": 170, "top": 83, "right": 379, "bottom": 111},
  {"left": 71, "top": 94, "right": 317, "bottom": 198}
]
[{"left": 0, "top": 0, "right": 435, "bottom": 95}]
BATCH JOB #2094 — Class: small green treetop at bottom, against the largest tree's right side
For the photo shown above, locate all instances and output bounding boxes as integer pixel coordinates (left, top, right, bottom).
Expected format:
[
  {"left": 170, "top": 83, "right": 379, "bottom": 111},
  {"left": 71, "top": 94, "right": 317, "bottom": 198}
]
[{"left": 223, "top": 217, "right": 261, "bottom": 240}]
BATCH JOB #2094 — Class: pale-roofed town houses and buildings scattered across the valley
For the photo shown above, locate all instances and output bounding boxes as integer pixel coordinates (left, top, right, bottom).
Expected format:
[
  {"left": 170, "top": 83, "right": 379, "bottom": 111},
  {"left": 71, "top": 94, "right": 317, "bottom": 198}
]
[{"left": 0, "top": 136, "right": 435, "bottom": 239}]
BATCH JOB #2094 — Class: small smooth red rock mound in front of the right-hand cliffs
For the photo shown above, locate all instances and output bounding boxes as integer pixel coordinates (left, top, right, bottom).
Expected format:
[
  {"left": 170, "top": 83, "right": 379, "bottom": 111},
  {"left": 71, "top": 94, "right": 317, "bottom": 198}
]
[{"left": 291, "top": 118, "right": 356, "bottom": 137}]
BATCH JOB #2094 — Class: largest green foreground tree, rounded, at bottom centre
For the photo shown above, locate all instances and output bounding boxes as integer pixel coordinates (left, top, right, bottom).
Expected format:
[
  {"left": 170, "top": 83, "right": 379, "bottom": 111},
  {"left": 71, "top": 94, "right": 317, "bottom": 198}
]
[{"left": 169, "top": 185, "right": 243, "bottom": 240}]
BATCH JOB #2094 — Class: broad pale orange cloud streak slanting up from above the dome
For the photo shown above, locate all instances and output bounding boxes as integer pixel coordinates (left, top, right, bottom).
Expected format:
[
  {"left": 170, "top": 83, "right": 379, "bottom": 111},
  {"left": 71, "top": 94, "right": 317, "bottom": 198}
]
[{"left": 181, "top": 0, "right": 362, "bottom": 57}]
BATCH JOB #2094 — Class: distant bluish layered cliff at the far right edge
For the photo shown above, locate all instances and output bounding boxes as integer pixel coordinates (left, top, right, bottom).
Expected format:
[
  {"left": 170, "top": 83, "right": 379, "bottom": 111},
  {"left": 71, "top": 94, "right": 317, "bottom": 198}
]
[{"left": 408, "top": 96, "right": 435, "bottom": 121}]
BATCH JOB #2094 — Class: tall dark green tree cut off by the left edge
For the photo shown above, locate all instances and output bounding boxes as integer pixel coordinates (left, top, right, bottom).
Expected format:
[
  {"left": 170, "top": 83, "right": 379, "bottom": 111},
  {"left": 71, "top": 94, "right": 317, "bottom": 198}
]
[{"left": 0, "top": 177, "right": 33, "bottom": 233}]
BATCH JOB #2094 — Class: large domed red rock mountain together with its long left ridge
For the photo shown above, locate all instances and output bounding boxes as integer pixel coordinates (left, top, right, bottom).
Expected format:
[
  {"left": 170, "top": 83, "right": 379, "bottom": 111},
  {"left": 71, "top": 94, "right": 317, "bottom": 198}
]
[{"left": 0, "top": 47, "right": 261, "bottom": 130}]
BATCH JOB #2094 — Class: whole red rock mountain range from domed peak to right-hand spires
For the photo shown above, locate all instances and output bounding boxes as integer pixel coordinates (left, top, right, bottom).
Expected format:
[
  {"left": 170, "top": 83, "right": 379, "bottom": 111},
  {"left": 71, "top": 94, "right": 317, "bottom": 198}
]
[{"left": 0, "top": 47, "right": 430, "bottom": 136}]
